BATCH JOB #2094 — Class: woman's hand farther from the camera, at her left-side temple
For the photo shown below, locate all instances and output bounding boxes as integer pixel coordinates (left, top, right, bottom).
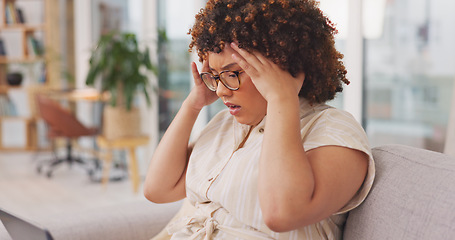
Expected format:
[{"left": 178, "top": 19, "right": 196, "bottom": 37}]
[{"left": 186, "top": 60, "right": 218, "bottom": 111}]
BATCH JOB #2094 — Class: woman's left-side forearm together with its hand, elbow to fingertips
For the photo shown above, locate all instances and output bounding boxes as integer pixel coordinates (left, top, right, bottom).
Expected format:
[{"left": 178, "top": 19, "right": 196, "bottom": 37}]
[{"left": 144, "top": 62, "right": 217, "bottom": 203}]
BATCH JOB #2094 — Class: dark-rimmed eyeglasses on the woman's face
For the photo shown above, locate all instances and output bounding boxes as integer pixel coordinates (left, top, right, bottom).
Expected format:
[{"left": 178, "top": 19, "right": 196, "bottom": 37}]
[{"left": 201, "top": 70, "right": 243, "bottom": 92}]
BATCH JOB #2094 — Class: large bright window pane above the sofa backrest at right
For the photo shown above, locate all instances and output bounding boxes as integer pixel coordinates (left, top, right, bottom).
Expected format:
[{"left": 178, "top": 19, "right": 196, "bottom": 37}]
[{"left": 364, "top": 0, "right": 455, "bottom": 151}]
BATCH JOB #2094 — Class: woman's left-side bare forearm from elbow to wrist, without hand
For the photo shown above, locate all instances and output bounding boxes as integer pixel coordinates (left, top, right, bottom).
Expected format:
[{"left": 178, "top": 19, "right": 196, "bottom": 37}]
[{"left": 144, "top": 101, "right": 199, "bottom": 202}]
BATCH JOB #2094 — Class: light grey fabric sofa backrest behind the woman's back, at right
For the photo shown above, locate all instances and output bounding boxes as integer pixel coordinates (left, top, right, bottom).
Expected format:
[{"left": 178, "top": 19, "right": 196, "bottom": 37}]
[{"left": 344, "top": 145, "right": 455, "bottom": 240}]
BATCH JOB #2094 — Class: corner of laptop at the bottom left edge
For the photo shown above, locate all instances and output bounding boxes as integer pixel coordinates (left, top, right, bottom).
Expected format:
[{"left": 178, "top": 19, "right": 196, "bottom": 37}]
[{"left": 0, "top": 208, "right": 53, "bottom": 240}]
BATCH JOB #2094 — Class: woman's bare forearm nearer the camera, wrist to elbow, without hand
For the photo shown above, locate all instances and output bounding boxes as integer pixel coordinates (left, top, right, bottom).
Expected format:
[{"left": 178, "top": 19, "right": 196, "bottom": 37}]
[{"left": 258, "top": 96, "right": 315, "bottom": 230}]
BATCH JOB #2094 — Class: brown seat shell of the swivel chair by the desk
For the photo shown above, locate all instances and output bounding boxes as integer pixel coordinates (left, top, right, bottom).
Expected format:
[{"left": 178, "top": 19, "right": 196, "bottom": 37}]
[{"left": 36, "top": 94, "right": 96, "bottom": 138}]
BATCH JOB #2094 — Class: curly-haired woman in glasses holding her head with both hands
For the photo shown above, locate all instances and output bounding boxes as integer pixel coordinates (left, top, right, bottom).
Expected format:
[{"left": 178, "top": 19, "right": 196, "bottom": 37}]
[{"left": 144, "top": 0, "right": 374, "bottom": 239}]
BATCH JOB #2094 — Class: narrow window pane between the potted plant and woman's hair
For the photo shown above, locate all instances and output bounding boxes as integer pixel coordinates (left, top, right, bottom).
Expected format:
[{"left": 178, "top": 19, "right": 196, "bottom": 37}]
[{"left": 158, "top": 0, "right": 196, "bottom": 136}]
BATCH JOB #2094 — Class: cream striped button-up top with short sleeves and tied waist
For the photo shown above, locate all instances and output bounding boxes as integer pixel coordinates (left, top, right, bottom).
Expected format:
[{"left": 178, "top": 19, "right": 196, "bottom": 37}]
[{"left": 168, "top": 100, "right": 375, "bottom": 239}]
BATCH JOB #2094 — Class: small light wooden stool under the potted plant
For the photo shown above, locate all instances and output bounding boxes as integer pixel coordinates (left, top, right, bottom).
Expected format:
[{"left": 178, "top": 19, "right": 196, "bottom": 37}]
[{"left": 97, "top": 136, "right": 149, "bottom": 193}]
